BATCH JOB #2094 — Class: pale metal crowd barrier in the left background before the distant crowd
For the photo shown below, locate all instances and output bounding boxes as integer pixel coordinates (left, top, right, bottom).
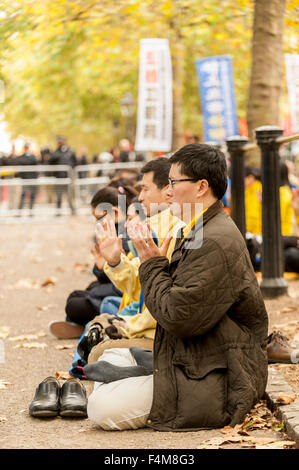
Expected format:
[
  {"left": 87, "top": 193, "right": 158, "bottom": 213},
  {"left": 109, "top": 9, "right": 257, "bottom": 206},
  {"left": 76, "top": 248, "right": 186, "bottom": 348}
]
[{"left": 0, "top": 162, "right": 145, "bottom": 219}]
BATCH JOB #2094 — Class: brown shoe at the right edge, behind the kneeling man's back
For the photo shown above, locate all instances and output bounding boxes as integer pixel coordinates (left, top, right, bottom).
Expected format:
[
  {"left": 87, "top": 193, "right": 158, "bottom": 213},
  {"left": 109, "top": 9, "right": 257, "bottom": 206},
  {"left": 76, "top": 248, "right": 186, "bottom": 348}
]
[{"left": 267, "top": 331, "right": 299, "bottom": 364}]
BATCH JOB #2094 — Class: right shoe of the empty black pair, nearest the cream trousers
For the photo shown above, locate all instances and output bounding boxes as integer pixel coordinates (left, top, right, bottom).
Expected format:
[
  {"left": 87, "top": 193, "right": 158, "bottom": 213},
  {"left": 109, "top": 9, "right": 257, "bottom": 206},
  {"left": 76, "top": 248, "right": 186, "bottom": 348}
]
[{"left": 60, "top": 378, "right": 87, "bottom": 418}]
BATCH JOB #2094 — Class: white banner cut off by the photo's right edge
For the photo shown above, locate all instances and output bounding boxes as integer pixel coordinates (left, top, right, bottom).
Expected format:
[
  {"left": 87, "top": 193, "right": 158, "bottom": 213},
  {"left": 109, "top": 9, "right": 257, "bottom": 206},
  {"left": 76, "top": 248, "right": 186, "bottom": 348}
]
[{"left": 285, "top": 54, "right": 299, "bottom": 132}]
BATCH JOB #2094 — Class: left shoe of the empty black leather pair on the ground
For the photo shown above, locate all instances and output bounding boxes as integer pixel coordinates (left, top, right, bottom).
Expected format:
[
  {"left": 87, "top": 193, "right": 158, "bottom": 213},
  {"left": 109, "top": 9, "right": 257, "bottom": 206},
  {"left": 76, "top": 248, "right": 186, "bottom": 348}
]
[{"left": 29, "top": 377, "right": 60, "bottom": 418}]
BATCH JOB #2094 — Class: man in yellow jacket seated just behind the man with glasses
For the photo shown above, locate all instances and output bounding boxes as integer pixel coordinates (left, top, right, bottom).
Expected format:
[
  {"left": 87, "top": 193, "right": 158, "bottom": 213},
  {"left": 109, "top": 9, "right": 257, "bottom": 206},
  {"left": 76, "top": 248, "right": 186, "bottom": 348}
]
[{"left": 70, "top": 158, "right": 184, "bottom": 377}]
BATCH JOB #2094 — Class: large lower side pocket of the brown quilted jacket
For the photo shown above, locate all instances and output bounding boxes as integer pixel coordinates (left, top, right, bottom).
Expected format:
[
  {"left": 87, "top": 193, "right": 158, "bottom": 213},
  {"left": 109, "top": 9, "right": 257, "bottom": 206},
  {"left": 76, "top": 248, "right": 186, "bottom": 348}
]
[{"left": 174, "top": 358, "right": 230, "bottom": 429}]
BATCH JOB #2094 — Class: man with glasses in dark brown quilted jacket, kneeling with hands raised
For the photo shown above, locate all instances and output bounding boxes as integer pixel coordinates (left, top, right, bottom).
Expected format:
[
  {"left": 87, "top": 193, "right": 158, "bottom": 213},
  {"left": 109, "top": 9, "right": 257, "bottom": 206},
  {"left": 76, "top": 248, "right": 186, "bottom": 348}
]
[{"left": 131, "top": 144, "right": 268, "bottom": 431}]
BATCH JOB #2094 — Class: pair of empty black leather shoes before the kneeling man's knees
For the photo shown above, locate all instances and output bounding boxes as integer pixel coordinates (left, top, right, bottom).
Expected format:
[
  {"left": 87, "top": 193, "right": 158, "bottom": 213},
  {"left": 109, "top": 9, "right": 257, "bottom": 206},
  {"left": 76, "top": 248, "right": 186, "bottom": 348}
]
[{"left": 29, "top": 377, "right": 87, "bottom": 418}]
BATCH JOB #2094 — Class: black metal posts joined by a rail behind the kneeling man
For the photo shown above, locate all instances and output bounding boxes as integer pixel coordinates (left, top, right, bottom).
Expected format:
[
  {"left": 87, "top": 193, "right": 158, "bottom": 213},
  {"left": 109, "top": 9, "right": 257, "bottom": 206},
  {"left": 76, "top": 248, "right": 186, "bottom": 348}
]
[{"left": 226, "top": 126, "right": 299, "bottom": 298}]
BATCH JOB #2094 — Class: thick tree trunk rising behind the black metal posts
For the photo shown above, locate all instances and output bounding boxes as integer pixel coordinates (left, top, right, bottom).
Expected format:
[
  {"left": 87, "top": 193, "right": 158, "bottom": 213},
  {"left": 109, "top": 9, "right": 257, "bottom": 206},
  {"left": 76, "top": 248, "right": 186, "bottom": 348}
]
[{"left": 246, "top": 0, "right": 285, "bottom": 166}]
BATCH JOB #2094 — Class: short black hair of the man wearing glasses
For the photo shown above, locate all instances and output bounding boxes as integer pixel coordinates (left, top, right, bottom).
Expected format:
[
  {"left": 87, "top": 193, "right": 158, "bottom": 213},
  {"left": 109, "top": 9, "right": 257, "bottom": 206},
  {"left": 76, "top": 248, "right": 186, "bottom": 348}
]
[{"left": 169, "top": 143, "right": 227, "bottom": 199}]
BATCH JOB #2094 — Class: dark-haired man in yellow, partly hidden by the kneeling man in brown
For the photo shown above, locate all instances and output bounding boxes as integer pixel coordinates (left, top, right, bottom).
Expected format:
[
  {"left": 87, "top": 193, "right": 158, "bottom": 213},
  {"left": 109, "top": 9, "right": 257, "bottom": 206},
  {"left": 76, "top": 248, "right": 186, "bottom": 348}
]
[{"left": 88, "top": 157, "right": 185, "bottom": 356}]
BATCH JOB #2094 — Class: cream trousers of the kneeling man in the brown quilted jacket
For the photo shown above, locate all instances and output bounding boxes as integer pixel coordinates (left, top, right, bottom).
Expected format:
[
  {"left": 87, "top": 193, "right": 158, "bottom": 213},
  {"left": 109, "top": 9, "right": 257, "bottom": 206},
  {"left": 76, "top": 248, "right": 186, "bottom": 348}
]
[{"left": 87, "top": 348, "right": 153, "bottom": 431}]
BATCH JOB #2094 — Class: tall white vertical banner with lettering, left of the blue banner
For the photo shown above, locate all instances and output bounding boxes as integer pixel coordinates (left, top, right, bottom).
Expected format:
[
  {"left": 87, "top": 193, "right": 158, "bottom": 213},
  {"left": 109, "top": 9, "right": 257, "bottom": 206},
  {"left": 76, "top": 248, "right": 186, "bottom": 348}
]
[{"left": 135, "top": 39, "right": 172, "bottom": 152}]
